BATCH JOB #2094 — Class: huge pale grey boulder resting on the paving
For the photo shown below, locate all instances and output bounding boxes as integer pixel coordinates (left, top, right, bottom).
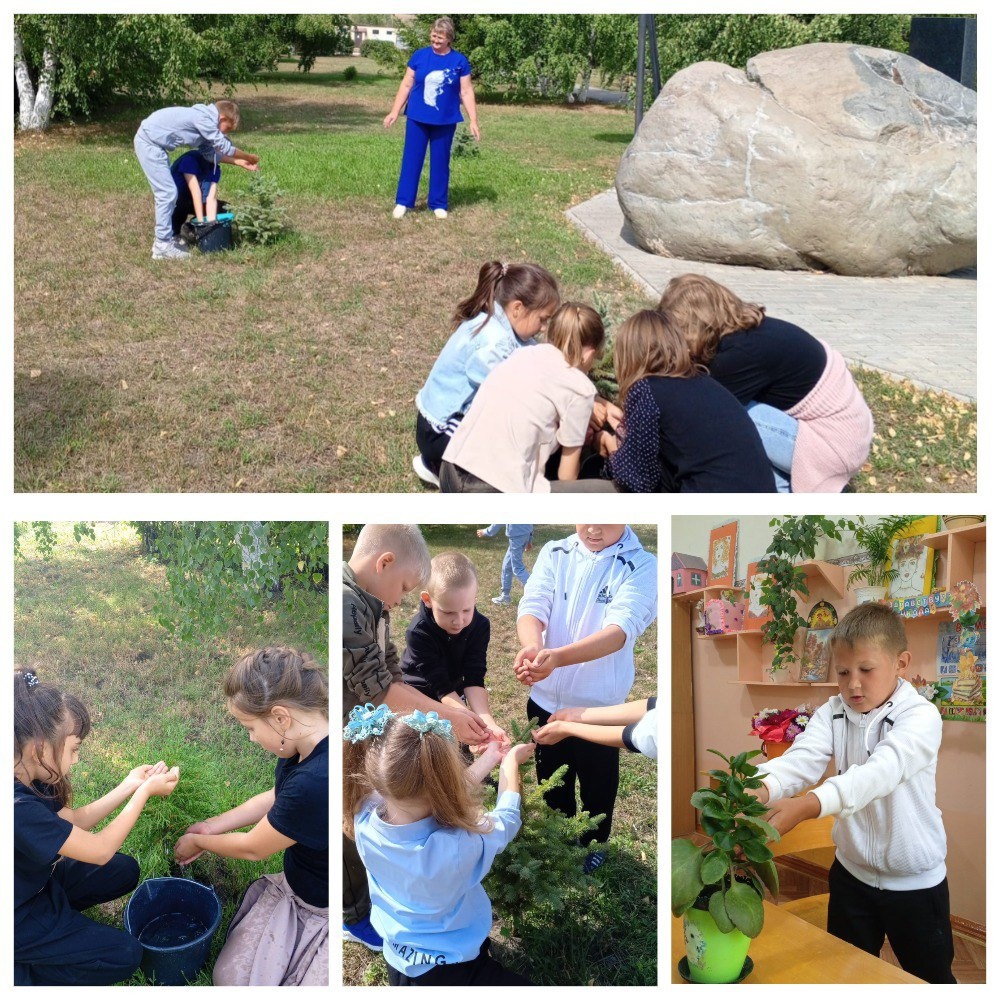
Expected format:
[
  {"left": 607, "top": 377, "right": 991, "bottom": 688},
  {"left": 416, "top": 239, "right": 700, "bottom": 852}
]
[{"left": 615, "top": 43, "right": 976, "bottom": 275}]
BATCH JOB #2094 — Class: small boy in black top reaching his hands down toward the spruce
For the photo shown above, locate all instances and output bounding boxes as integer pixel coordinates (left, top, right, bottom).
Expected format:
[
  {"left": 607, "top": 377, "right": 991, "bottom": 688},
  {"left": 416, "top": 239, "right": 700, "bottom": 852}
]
[{"left": 402, "top": 552, "right": 509, "bottom": 746}]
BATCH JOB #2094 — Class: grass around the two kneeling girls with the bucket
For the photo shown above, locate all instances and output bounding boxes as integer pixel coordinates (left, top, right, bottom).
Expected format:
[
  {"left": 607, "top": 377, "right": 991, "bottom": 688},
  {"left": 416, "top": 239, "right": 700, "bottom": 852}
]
[{"left": 14, "top": 524, "right": 328, "bottom": 985}]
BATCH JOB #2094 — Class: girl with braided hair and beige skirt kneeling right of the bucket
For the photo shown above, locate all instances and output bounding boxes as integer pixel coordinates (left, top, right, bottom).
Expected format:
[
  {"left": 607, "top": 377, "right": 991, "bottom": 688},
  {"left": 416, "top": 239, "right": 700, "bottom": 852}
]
[{"left": 174, "top": 647, "right": 330, "bottom": 986}]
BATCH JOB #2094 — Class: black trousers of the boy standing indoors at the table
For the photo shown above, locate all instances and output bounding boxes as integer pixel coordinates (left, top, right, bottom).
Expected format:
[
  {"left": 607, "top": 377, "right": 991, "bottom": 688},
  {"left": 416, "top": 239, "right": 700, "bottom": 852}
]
[{"left": 826, "top": 861, "right": 955, "bottom": 983}]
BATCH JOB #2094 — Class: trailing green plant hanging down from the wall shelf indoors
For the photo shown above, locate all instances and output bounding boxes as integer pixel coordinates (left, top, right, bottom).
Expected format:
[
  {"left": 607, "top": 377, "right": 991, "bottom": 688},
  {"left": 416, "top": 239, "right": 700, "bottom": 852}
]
[{"left": 757, "top": 514, "right": 854, "bottom": 672}]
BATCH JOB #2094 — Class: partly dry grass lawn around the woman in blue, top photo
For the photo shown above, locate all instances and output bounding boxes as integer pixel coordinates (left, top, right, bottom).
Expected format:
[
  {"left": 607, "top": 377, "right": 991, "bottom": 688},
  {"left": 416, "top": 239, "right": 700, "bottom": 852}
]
[{"left": 14, "top": 59, "right": 975, "bottom": 492}]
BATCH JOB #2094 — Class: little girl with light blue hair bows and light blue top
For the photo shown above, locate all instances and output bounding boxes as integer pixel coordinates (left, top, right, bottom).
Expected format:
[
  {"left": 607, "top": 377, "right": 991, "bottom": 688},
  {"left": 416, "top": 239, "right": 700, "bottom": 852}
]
[{"left": 344, "top": 705, "right": 534, "bottom": 986}]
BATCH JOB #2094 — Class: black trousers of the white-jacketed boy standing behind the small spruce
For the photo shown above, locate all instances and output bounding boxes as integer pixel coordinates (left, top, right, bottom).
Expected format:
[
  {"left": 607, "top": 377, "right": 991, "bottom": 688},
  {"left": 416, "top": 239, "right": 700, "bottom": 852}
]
[{"left": 528, "top": 698, "right": 619, "bottom": 845}]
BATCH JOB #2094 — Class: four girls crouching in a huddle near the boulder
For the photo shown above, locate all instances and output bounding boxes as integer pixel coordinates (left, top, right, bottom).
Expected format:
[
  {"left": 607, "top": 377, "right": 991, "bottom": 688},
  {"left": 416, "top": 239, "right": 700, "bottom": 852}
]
[{"left": 413, "top": 261, "right": 873, "bottom": 493}]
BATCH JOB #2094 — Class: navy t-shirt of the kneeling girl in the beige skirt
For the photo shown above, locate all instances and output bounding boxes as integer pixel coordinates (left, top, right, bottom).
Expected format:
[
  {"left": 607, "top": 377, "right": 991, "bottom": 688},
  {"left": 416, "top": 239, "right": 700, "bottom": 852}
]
[{"left": 267, "top": 737, "right": 330, "bottom": 907}]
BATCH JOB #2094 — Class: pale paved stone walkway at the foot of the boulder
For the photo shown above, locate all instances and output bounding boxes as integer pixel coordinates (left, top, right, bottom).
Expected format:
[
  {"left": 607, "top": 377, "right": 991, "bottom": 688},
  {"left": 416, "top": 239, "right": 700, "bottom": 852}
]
[{"left": 566, "top": 190, "right": 976, "bottom": 400}]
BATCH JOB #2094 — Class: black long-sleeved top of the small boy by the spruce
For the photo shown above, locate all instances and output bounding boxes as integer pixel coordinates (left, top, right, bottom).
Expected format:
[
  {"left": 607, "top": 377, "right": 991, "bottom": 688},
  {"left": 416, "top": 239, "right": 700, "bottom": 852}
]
[{"left": 402, "top": 601, "right": 490, "bottom": 701}]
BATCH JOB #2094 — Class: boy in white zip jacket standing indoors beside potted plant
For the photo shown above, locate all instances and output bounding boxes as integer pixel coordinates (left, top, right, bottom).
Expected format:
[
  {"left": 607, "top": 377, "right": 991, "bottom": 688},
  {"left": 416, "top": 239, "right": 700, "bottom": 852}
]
[{"left": 755, "top": 604, "right": 955, "bottom": 983}]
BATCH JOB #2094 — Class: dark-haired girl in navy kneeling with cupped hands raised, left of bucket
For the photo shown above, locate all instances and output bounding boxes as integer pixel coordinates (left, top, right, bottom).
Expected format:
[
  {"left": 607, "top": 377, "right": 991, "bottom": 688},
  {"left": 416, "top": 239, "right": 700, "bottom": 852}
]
[{"left": 14, "top": 670, "right": 178, "bottom": 986}]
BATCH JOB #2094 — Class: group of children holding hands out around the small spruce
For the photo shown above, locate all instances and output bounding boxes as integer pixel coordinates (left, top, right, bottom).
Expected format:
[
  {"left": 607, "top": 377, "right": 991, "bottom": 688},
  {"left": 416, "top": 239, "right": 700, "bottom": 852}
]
[{"left": 343, "top": 524, "right": 656, "bottom": 986}]
